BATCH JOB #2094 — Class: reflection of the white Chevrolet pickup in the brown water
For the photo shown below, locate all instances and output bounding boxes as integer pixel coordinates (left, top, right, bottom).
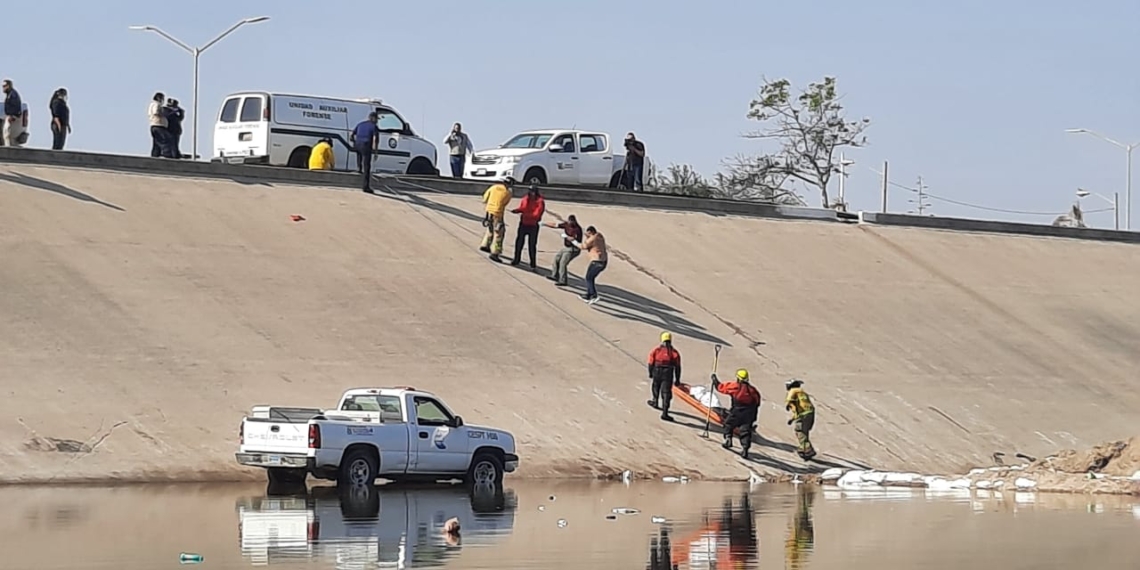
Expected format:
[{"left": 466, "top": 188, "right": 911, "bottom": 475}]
[{"left": 237, "top": 486, "right": 518, "bottom": 570}]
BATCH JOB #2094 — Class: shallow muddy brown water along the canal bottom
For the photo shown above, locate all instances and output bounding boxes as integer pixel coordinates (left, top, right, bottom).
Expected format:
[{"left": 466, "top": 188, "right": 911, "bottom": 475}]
[{"left": 0, "top": 482, "right": 1140, "bottom": 570}]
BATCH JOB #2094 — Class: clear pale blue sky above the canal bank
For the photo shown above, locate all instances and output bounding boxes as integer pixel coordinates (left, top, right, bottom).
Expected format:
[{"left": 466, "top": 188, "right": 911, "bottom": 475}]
[{"left": 8, "top": 0, "right": 1140, "bottom": 227}]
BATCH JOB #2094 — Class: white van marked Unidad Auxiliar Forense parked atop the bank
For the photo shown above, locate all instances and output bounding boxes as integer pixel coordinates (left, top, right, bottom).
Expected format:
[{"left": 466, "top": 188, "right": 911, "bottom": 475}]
[{"left": 212, "top": 91, "right": 439, "bottom": 174}]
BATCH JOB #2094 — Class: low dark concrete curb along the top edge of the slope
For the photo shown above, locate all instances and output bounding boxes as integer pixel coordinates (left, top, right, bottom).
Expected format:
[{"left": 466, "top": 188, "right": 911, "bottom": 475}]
[{"left": 0, "top": 147, "right": 1140, "bottom": 243}]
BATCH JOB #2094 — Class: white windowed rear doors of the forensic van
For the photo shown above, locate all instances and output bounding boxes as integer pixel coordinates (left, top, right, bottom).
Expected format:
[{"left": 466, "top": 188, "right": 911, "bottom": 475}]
[{"left": 214, "top": 93, "right": 269, "bottom": 162}]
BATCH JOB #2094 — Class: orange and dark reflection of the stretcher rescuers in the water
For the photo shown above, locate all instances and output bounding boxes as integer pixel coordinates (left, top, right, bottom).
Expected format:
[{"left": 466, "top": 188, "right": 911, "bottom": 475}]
[{"left": 649, "top": 491, "right": 759, "bottom": 570}]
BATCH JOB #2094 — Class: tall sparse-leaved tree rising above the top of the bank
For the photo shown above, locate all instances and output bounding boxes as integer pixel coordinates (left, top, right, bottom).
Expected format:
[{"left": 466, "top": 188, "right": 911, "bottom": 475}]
[{"left": 736, "top": 76, "right": 871, "bottom": 207}]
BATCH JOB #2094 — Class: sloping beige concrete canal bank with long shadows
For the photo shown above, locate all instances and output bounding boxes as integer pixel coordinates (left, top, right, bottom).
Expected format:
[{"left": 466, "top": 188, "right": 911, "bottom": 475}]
[{"left": 0, "top": 164, "right": 1140, "bottom": 482}]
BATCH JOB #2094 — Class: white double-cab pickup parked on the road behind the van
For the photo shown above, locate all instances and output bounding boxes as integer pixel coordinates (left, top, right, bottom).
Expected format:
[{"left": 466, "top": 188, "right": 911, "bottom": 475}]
[{"left": 463, "top": 129, "right": 626, "bottom": 188}]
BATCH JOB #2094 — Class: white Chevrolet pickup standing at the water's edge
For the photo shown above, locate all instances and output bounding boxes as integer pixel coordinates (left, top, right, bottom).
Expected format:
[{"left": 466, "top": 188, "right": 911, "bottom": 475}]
[{"left": 236, "top": 386, "right": 519, "bottom": 486}]
